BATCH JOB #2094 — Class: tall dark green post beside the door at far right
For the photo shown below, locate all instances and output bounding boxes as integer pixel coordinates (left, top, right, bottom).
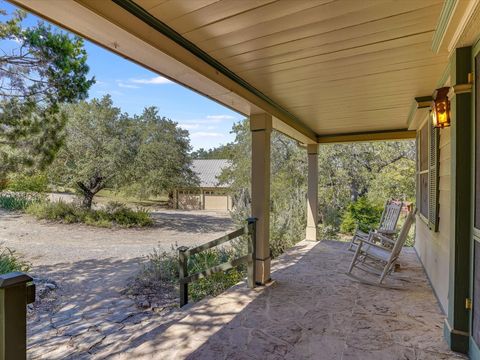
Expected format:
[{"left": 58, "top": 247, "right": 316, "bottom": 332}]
[{"left": 444, "top": 47, "right": 475, "bottom": 353}]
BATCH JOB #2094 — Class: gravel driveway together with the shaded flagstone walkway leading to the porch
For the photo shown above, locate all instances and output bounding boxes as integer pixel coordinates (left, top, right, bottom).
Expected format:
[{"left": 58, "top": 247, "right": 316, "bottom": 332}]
[{"left": 0, "top": 210, "right": 233, "bottom": 359}]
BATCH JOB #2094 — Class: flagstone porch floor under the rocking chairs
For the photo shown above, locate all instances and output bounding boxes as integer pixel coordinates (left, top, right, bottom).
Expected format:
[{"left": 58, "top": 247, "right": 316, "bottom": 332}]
[{"left": 109, "top": 241, "right": 464, "bottom": 360}]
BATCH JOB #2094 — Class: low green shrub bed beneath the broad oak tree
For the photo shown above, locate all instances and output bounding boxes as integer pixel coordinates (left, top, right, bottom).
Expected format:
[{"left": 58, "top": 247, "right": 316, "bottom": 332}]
[{"left": 26, "top": 200, "right": 153, "bottom": 228}]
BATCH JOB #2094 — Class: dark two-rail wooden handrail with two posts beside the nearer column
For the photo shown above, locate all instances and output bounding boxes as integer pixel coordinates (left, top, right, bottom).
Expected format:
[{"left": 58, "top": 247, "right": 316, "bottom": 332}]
[{"left": 178, "top": 218, "right": 257, "bottom": 307}]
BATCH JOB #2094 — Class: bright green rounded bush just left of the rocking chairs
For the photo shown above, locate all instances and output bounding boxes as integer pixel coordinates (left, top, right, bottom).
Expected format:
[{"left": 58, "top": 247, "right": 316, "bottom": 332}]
[{"left": 340, "top": 197, "right": 382, "bottom": 234}]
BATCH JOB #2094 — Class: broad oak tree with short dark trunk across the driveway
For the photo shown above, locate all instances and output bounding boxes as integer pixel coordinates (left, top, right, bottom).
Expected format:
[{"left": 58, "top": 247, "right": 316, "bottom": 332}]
[{"left": 51, "top": 96, "right": 196, "bottom": 208}]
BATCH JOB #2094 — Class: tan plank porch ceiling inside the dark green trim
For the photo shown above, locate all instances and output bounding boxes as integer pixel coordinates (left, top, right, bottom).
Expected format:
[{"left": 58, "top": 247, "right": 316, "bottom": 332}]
[{"left": 129, "top": 0, "right": 447, "bottom": 135}]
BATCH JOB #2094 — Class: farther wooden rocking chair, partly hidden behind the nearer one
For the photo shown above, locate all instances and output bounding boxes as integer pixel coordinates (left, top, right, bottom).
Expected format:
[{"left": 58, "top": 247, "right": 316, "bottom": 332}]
[{"left": 348, "top": 200, "right": 403, "bottom": 251}]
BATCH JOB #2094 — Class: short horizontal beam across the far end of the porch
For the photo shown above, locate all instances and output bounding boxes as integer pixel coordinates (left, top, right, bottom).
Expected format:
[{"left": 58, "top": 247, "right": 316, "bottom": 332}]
[{"left": 317, "top": 129, "right": 416, "bottom": 144}]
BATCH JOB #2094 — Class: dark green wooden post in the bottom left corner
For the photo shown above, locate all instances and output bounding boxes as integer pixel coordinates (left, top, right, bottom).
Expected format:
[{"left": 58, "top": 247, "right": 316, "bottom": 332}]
[{"left": 0, "top": 272, "right": 35, "bottom": 360}]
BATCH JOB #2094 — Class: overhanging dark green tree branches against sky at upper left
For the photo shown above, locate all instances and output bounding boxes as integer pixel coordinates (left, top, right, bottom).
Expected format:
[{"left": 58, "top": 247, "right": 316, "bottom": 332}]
[{"left": 0, "top": 9, "right": 94, "bottom": 177}]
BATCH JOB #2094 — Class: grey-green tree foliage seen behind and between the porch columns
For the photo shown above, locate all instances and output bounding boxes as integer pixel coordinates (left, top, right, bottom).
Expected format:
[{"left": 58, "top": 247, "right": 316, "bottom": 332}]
[{"left": 222, "top": 120, "right": 415, "bottom": 255}]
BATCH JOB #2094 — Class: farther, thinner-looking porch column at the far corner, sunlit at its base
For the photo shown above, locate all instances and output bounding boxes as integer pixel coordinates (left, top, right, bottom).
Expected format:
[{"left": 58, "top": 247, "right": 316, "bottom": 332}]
[{"left": 305, "top": 144, "right": 318, "bottom": 241}]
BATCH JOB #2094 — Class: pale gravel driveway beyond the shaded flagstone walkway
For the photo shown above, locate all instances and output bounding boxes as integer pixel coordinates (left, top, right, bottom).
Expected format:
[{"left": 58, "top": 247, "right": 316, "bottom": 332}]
[{"left": 0, "top": 210, "right": 232, "bottom": 266}]
